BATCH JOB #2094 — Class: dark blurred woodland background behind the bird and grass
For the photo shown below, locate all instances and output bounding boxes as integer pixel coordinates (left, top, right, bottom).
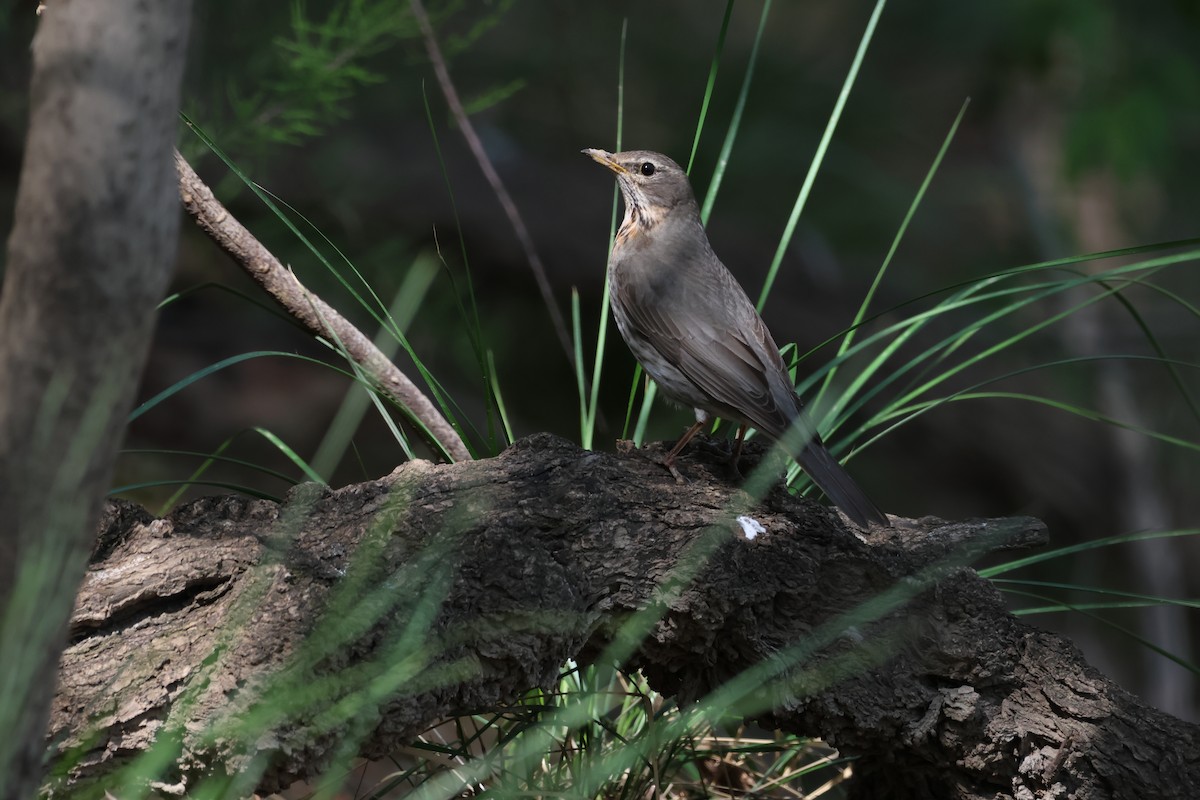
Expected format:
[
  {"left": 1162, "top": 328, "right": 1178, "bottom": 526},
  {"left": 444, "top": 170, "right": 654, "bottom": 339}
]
[{"left": 0, "top": 0, "right": 1200, "bottom": 743}]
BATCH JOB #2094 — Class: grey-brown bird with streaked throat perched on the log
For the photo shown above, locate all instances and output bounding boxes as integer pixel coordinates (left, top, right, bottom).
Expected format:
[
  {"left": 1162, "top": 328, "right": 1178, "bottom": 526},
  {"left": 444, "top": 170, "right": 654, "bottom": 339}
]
[{"left": 581, "top": 148, "right": 889, "bottom": 528}]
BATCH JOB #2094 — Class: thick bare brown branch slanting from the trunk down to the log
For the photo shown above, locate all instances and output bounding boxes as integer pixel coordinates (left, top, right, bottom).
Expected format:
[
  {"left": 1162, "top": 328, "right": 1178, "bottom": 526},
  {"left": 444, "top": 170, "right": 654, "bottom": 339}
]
[{"left": 175, "top": 151, "right": 470, "bottom": 461}]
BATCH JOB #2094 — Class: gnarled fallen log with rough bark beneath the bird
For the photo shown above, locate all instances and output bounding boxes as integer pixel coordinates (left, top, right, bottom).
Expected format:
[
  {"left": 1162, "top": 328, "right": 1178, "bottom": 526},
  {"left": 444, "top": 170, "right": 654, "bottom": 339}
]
[{"left": 52, "top": 435, "right": 1200, "bottom": 798}]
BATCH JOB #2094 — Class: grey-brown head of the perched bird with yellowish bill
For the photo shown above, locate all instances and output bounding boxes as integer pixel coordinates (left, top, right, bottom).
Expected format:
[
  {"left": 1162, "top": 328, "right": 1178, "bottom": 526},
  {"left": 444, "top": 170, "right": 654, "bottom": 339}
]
[{"left": 582, "top": 149, "right": 698, "bottom": 233}]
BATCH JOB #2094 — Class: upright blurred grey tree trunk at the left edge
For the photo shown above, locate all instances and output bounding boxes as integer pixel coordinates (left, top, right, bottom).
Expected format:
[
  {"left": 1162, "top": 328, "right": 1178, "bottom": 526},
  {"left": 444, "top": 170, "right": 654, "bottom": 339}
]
[{"left": 0, "top": 0, "right": 190, "bottom": 800}]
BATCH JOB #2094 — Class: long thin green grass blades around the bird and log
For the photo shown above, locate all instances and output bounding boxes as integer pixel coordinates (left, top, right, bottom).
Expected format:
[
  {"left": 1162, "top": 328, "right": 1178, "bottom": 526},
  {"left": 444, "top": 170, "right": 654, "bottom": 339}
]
[{"left": 60, "top": 0, "right": 1200, "bottom": 798}]
